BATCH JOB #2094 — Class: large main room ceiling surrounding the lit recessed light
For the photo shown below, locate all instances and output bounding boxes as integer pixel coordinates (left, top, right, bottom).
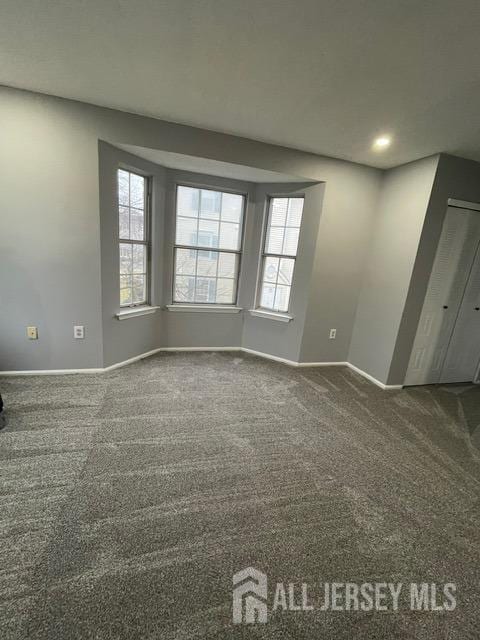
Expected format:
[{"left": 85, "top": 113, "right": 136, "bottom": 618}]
[{"left": 0, "top": 0, "right": 480, "bottom": 167}]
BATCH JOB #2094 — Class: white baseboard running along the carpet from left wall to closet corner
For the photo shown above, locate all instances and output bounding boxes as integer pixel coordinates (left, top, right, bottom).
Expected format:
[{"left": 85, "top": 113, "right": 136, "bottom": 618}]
[{"left": 0, "top": 347, "right": 403, "bottom": 391}]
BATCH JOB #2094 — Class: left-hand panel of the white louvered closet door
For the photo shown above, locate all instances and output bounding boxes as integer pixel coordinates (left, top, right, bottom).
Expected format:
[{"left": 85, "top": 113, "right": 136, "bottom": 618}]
[{"left": 405, "top": 207, "right": 480, "bottom": 385}]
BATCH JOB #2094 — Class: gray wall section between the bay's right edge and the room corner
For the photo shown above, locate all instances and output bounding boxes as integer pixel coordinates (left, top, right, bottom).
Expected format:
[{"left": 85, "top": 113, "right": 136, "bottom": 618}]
[{"left": 300, "top": 165, "right": 381, "bottom": 362}]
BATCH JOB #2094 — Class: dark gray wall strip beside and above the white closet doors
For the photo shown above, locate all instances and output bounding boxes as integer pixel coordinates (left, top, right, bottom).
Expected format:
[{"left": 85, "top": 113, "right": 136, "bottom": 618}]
[{"left": 388, "top": 154, "right": 480, "bottom": 384}]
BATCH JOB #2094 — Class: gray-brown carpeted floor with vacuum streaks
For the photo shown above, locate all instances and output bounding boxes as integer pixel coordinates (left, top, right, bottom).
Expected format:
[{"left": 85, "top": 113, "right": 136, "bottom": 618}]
[{"left": 0, "top": 353, "right": 480, "bottom": 640}]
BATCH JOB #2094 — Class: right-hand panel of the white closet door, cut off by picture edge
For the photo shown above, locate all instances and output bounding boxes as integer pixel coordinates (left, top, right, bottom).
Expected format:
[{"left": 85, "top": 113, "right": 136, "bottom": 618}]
[{"left": 440, "top": 239, "right": 480, "bottom": 383}]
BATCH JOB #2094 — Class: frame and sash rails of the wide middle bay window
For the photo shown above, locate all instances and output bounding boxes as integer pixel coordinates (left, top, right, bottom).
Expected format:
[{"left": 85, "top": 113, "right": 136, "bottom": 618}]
[{"left": 171, "top": 181, "right": 248, "bottom": 309}]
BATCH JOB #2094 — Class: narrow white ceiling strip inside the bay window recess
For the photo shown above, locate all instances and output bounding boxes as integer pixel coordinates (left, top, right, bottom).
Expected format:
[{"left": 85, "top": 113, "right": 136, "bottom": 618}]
[{"left": 115, "top": 144, "right": 311, "bottom": 183}]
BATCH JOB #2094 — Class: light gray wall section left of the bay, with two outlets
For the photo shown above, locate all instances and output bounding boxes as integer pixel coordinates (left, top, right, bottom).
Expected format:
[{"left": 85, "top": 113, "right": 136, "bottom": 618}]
[{"left": 0, "top": 89, "right": 103, "bottom": 370}]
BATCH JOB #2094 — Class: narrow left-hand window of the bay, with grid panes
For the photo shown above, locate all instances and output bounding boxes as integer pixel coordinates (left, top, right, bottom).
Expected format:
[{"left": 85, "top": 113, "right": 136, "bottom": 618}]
[{"left": 117, "top": 169, "right": 150, "bottom": 307}]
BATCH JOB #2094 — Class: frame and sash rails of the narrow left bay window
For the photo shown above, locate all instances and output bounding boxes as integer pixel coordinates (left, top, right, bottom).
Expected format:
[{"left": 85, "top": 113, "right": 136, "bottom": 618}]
[{"left": 115, "top": 164, "right": 152, "bottom": 309}]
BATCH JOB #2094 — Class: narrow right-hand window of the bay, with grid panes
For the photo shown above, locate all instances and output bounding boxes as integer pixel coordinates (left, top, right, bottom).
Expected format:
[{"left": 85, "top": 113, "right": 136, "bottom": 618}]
[{"left": 260, "top": 198, "right": 303, "bottom": 313}]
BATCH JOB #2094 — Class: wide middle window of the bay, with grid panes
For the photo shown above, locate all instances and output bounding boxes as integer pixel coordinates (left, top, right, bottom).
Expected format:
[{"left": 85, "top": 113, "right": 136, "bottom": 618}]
[{"left": 173, "top": 185, "right": 245, "bottom": 304}]
